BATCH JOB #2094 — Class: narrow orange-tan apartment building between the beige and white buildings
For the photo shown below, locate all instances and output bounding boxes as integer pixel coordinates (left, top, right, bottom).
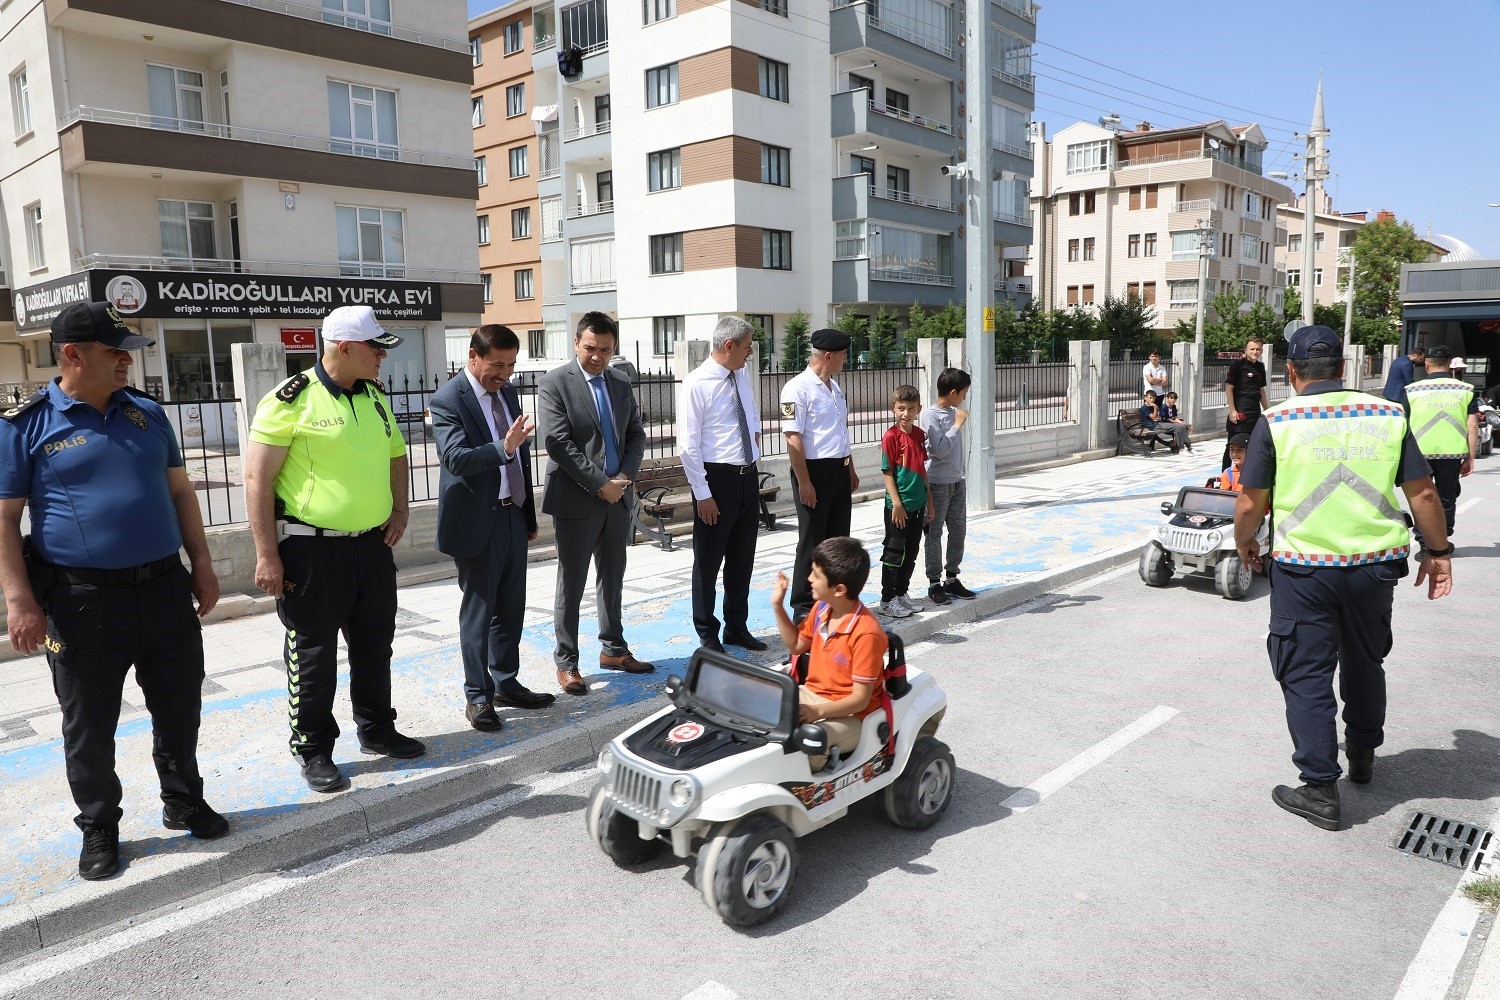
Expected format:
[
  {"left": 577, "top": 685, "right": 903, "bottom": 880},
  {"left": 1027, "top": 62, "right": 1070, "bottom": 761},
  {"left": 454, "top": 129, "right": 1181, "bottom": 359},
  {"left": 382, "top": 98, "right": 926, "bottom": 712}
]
[{"left": 464, "top": 0, "right": 555, "bottom": 361}]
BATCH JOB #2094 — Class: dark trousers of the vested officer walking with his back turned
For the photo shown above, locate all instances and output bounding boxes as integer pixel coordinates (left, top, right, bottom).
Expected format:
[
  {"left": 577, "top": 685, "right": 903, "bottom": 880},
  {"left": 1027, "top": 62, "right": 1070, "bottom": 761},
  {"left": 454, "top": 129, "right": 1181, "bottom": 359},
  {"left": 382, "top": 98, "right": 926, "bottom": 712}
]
[{"left": 1266, "top": 559, "right": 1407, "bottom": 783}]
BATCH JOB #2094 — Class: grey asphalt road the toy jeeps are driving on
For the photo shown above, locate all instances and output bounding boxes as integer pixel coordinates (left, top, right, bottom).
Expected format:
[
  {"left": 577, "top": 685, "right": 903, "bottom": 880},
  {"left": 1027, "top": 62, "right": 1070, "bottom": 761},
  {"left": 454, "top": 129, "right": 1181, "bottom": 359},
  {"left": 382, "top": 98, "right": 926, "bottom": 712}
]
[{"left": 0, "top": 462, "right": 1500, "bottom": 1000}]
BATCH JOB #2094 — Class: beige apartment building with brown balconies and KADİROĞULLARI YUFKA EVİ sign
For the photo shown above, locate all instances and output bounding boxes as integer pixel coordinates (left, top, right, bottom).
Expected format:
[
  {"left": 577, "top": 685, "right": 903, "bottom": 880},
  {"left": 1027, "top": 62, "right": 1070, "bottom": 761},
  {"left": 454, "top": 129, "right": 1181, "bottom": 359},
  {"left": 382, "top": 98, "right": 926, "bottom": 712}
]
[{"left": 0, "top": 0, "right": 482, "bottom": 400}]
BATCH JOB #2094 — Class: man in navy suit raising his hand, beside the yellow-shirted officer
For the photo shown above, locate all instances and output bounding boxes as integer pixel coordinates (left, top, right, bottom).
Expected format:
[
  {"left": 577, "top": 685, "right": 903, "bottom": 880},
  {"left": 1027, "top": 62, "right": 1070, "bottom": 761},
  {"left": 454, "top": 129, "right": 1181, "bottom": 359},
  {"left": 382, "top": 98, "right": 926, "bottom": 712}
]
[{"left": 431, "top": 324, "right": 555, "bottom": 733}]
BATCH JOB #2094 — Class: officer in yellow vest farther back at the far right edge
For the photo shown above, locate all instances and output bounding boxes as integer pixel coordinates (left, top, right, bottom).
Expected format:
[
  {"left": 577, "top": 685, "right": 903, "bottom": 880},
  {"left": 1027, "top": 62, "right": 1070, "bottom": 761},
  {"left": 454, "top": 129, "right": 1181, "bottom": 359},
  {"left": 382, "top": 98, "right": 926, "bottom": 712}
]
[{"left": 1406, "top": 343, "right": 1479, "bottom": 549}]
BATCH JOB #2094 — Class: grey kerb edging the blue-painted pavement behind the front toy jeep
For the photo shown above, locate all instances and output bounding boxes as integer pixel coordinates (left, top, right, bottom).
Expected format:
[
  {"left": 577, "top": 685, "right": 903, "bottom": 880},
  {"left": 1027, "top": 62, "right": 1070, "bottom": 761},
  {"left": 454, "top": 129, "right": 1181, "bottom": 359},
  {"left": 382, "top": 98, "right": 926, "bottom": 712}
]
[{"left": 0, "top": 543, "right": 1140, "bottom": 964}]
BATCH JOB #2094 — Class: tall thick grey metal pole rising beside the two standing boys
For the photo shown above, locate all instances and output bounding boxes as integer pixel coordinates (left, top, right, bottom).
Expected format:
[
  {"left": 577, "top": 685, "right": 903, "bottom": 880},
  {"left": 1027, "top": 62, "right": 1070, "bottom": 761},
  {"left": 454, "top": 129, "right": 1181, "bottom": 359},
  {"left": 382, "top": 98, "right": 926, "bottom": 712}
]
[{"left": 963, "top": 0, "right": 995, "bottom": 511}]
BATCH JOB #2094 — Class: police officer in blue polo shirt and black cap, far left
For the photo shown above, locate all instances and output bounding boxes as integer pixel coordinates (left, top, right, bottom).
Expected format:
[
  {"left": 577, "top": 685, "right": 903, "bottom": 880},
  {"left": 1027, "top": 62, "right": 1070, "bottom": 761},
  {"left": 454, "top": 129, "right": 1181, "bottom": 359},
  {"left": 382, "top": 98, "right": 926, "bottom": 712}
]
[{"left": 0, "top": 303, "right": 230, "bottom": 879}]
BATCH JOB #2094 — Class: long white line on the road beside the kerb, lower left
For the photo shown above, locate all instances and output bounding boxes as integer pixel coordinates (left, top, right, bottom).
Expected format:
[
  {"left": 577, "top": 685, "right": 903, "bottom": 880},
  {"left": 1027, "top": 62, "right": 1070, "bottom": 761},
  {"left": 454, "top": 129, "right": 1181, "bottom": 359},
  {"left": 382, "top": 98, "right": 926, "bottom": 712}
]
[{"left": 0, "top": 768, "right": 596, "bottom": 996}]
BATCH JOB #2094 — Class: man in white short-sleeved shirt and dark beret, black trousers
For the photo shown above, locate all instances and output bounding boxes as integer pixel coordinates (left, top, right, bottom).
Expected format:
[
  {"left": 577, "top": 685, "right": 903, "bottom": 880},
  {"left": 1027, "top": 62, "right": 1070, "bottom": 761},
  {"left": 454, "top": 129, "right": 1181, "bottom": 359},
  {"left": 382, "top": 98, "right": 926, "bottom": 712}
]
[{"left": 782, "top": 330, "right": 860, "bottom": 622}]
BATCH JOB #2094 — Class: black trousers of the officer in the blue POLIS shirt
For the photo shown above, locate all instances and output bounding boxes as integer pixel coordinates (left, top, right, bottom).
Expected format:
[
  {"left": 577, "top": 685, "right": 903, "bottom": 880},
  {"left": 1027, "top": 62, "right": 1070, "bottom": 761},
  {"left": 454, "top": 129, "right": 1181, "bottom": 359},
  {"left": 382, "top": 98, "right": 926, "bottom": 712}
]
[{"left": 42, "top": 565, "right": 203, "bottom": 831}]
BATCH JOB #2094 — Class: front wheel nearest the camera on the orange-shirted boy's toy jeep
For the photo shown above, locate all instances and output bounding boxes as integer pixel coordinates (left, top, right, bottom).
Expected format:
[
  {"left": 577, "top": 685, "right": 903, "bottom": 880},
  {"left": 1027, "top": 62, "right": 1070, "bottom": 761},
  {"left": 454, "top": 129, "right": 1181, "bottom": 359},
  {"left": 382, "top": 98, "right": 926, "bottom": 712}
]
[{"left": 696, "top": 813, "right": 798, "bottom": 927}]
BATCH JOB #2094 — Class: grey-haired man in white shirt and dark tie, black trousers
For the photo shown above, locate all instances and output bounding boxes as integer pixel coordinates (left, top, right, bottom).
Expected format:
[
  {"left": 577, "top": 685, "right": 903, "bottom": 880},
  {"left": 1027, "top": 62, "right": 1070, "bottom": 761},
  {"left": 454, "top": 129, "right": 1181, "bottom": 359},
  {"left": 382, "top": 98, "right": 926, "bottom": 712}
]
[{"left": 677, "top": 316, "right": 767, "bottom": 652}]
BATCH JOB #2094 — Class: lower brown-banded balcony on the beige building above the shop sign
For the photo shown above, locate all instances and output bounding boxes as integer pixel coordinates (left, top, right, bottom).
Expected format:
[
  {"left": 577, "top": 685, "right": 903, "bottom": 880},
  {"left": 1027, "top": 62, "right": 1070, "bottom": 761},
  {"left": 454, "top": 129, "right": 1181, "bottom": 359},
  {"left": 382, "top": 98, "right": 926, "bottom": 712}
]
[{"left": 59, "top": 106, "right": 479, "bottom": 199}]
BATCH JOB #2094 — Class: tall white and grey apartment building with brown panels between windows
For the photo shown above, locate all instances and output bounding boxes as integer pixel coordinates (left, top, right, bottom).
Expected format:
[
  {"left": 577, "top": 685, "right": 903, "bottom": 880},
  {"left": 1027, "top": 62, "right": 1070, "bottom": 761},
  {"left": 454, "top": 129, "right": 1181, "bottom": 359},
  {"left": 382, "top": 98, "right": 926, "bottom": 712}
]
[{"left": 522, "top": 0, "right": 1035, "bottom": 364}]
